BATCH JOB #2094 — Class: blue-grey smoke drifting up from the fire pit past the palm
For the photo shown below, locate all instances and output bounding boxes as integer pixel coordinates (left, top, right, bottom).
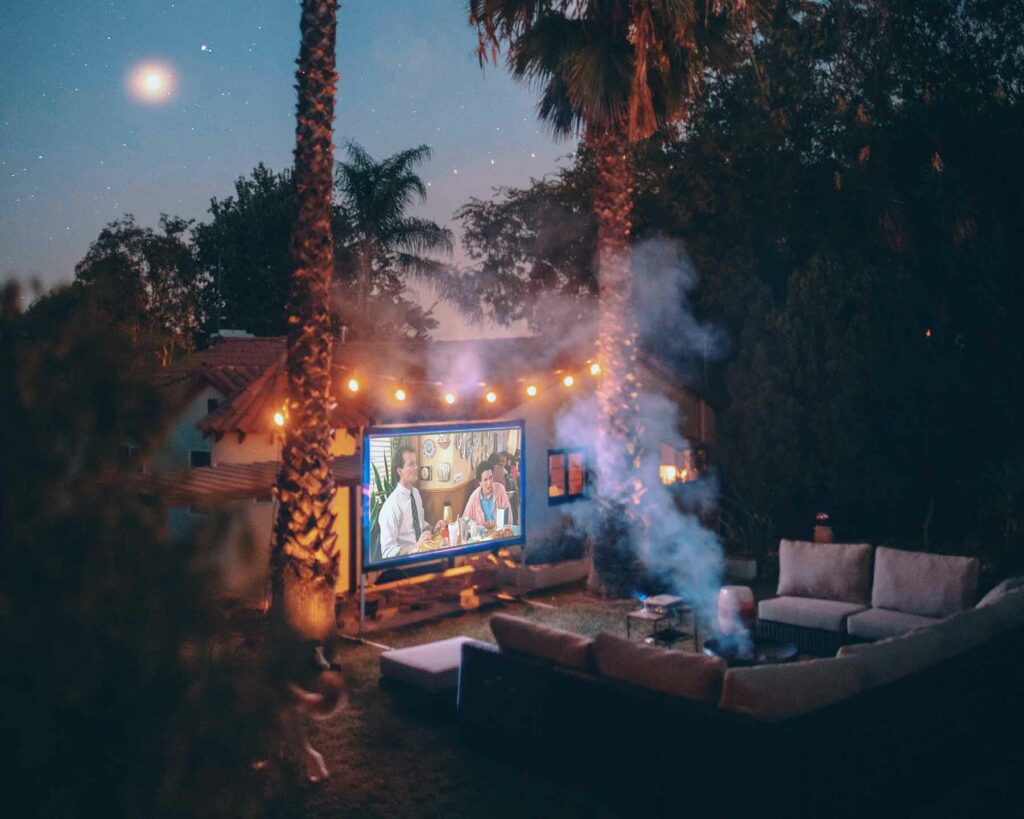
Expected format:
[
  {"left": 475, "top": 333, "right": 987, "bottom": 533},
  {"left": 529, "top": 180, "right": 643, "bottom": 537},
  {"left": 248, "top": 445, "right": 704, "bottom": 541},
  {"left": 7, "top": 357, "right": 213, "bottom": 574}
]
[{"left": 428, "top": 224, "right": 728, "bottom": 624}]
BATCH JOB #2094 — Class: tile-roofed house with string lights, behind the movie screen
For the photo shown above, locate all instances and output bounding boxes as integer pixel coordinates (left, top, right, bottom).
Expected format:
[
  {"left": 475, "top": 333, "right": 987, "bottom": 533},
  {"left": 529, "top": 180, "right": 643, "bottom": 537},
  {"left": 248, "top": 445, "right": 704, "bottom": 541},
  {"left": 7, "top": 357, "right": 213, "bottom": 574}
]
[{"left": 150, "top": 337, "right": 715, "bottom": 594}]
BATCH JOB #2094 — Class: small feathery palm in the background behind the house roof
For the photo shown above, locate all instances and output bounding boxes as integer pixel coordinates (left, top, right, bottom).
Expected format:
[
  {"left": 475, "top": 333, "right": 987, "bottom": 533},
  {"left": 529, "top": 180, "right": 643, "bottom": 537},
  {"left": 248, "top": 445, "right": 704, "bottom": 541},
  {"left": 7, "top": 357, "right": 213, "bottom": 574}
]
[{"left": 335, "top": 142, "right": 452, "bottom": 338}]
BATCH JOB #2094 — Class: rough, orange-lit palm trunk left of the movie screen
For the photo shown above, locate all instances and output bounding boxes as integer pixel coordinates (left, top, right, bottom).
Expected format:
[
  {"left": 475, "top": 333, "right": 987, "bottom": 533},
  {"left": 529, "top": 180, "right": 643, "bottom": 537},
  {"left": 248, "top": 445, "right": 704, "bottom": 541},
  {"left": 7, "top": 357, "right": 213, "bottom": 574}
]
[{"left": 270, "top": 0, "right": 338, "bottom": 639}]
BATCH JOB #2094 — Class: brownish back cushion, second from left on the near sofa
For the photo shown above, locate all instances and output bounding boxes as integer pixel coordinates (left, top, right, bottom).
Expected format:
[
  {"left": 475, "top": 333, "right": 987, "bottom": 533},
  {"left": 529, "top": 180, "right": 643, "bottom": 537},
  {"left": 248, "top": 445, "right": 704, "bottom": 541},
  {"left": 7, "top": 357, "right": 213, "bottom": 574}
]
[{"left": 594, "top": 632, "right": 725, "bottom": 702}]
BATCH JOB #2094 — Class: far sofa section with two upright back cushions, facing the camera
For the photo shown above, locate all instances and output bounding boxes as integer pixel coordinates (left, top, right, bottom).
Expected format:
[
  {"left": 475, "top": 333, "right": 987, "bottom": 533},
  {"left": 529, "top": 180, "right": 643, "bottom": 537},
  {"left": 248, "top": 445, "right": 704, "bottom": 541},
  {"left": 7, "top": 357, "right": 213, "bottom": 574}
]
[{"left": 758, "top": 541, "right": 979, "bottom": 656}]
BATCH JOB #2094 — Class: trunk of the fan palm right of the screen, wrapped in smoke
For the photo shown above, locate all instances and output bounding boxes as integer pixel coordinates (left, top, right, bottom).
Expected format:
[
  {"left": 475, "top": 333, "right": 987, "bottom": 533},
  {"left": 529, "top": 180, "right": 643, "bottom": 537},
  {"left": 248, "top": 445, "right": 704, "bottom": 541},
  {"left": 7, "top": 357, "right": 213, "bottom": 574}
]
[{"left": 587, "top": 123, "right": 644, "bottom": 594}]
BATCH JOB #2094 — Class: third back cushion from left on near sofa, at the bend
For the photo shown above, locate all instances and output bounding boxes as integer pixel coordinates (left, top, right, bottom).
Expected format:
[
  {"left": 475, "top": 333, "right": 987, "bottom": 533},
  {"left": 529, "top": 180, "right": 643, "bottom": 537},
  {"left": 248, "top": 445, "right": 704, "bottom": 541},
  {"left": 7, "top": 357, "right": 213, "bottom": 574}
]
[{"left": 719, "top": 657, "right": 864, "bottom": 721}]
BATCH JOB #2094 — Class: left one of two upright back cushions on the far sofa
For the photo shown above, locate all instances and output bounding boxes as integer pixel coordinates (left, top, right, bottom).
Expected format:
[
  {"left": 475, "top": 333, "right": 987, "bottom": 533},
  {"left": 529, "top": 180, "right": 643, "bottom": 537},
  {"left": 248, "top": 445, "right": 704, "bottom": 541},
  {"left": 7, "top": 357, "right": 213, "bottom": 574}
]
[{"left": 777, "top": 541, "right": 871, "bottom": 604}]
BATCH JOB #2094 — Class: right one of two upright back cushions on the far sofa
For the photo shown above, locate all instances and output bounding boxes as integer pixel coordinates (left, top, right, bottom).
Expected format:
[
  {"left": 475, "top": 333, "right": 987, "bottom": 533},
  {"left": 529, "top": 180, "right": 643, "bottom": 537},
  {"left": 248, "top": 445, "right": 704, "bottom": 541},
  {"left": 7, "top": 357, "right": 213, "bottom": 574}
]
[{"left": 871, "top": 546, "right": 979, "bottom": 617}]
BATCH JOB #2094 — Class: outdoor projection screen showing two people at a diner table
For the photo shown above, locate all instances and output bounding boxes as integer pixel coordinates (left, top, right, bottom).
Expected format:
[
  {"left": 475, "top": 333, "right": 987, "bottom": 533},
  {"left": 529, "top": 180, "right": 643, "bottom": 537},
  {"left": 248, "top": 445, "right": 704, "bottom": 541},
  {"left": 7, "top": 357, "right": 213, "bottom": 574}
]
[{"left": 362, "top": 422, "right": 524, "bottom": 571}]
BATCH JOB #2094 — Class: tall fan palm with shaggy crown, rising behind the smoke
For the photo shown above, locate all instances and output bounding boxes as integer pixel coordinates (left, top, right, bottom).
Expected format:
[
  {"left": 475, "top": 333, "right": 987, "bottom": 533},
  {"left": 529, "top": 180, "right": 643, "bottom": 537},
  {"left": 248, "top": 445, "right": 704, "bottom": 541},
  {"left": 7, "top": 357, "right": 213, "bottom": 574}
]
[{"left": 469, "top": 0, "right": 763, "bottom": 583}]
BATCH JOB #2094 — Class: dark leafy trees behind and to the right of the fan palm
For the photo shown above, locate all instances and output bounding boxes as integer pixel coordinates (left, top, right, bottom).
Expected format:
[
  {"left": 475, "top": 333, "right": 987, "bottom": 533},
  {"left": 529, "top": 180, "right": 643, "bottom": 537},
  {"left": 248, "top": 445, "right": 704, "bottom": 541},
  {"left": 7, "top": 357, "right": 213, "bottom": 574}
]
[{"left": 460, "top": 0, "right": 1024, "bottom": 565}]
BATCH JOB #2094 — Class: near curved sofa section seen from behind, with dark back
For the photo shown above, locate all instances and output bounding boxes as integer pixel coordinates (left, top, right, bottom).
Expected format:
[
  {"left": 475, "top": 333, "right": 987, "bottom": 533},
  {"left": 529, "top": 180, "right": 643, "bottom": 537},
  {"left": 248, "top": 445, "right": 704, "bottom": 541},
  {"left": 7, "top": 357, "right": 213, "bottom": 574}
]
[{"left": 458, "top": 584, "right": 1024, "bottom": 817}]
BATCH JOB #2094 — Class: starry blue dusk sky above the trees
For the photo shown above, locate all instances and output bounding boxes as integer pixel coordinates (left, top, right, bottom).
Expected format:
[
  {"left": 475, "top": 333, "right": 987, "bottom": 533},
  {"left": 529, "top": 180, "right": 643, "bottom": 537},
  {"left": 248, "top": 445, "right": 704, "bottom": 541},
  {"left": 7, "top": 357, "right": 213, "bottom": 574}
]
[{"left": 0, "top": 0, "right": 573, "bottom": 296}]
